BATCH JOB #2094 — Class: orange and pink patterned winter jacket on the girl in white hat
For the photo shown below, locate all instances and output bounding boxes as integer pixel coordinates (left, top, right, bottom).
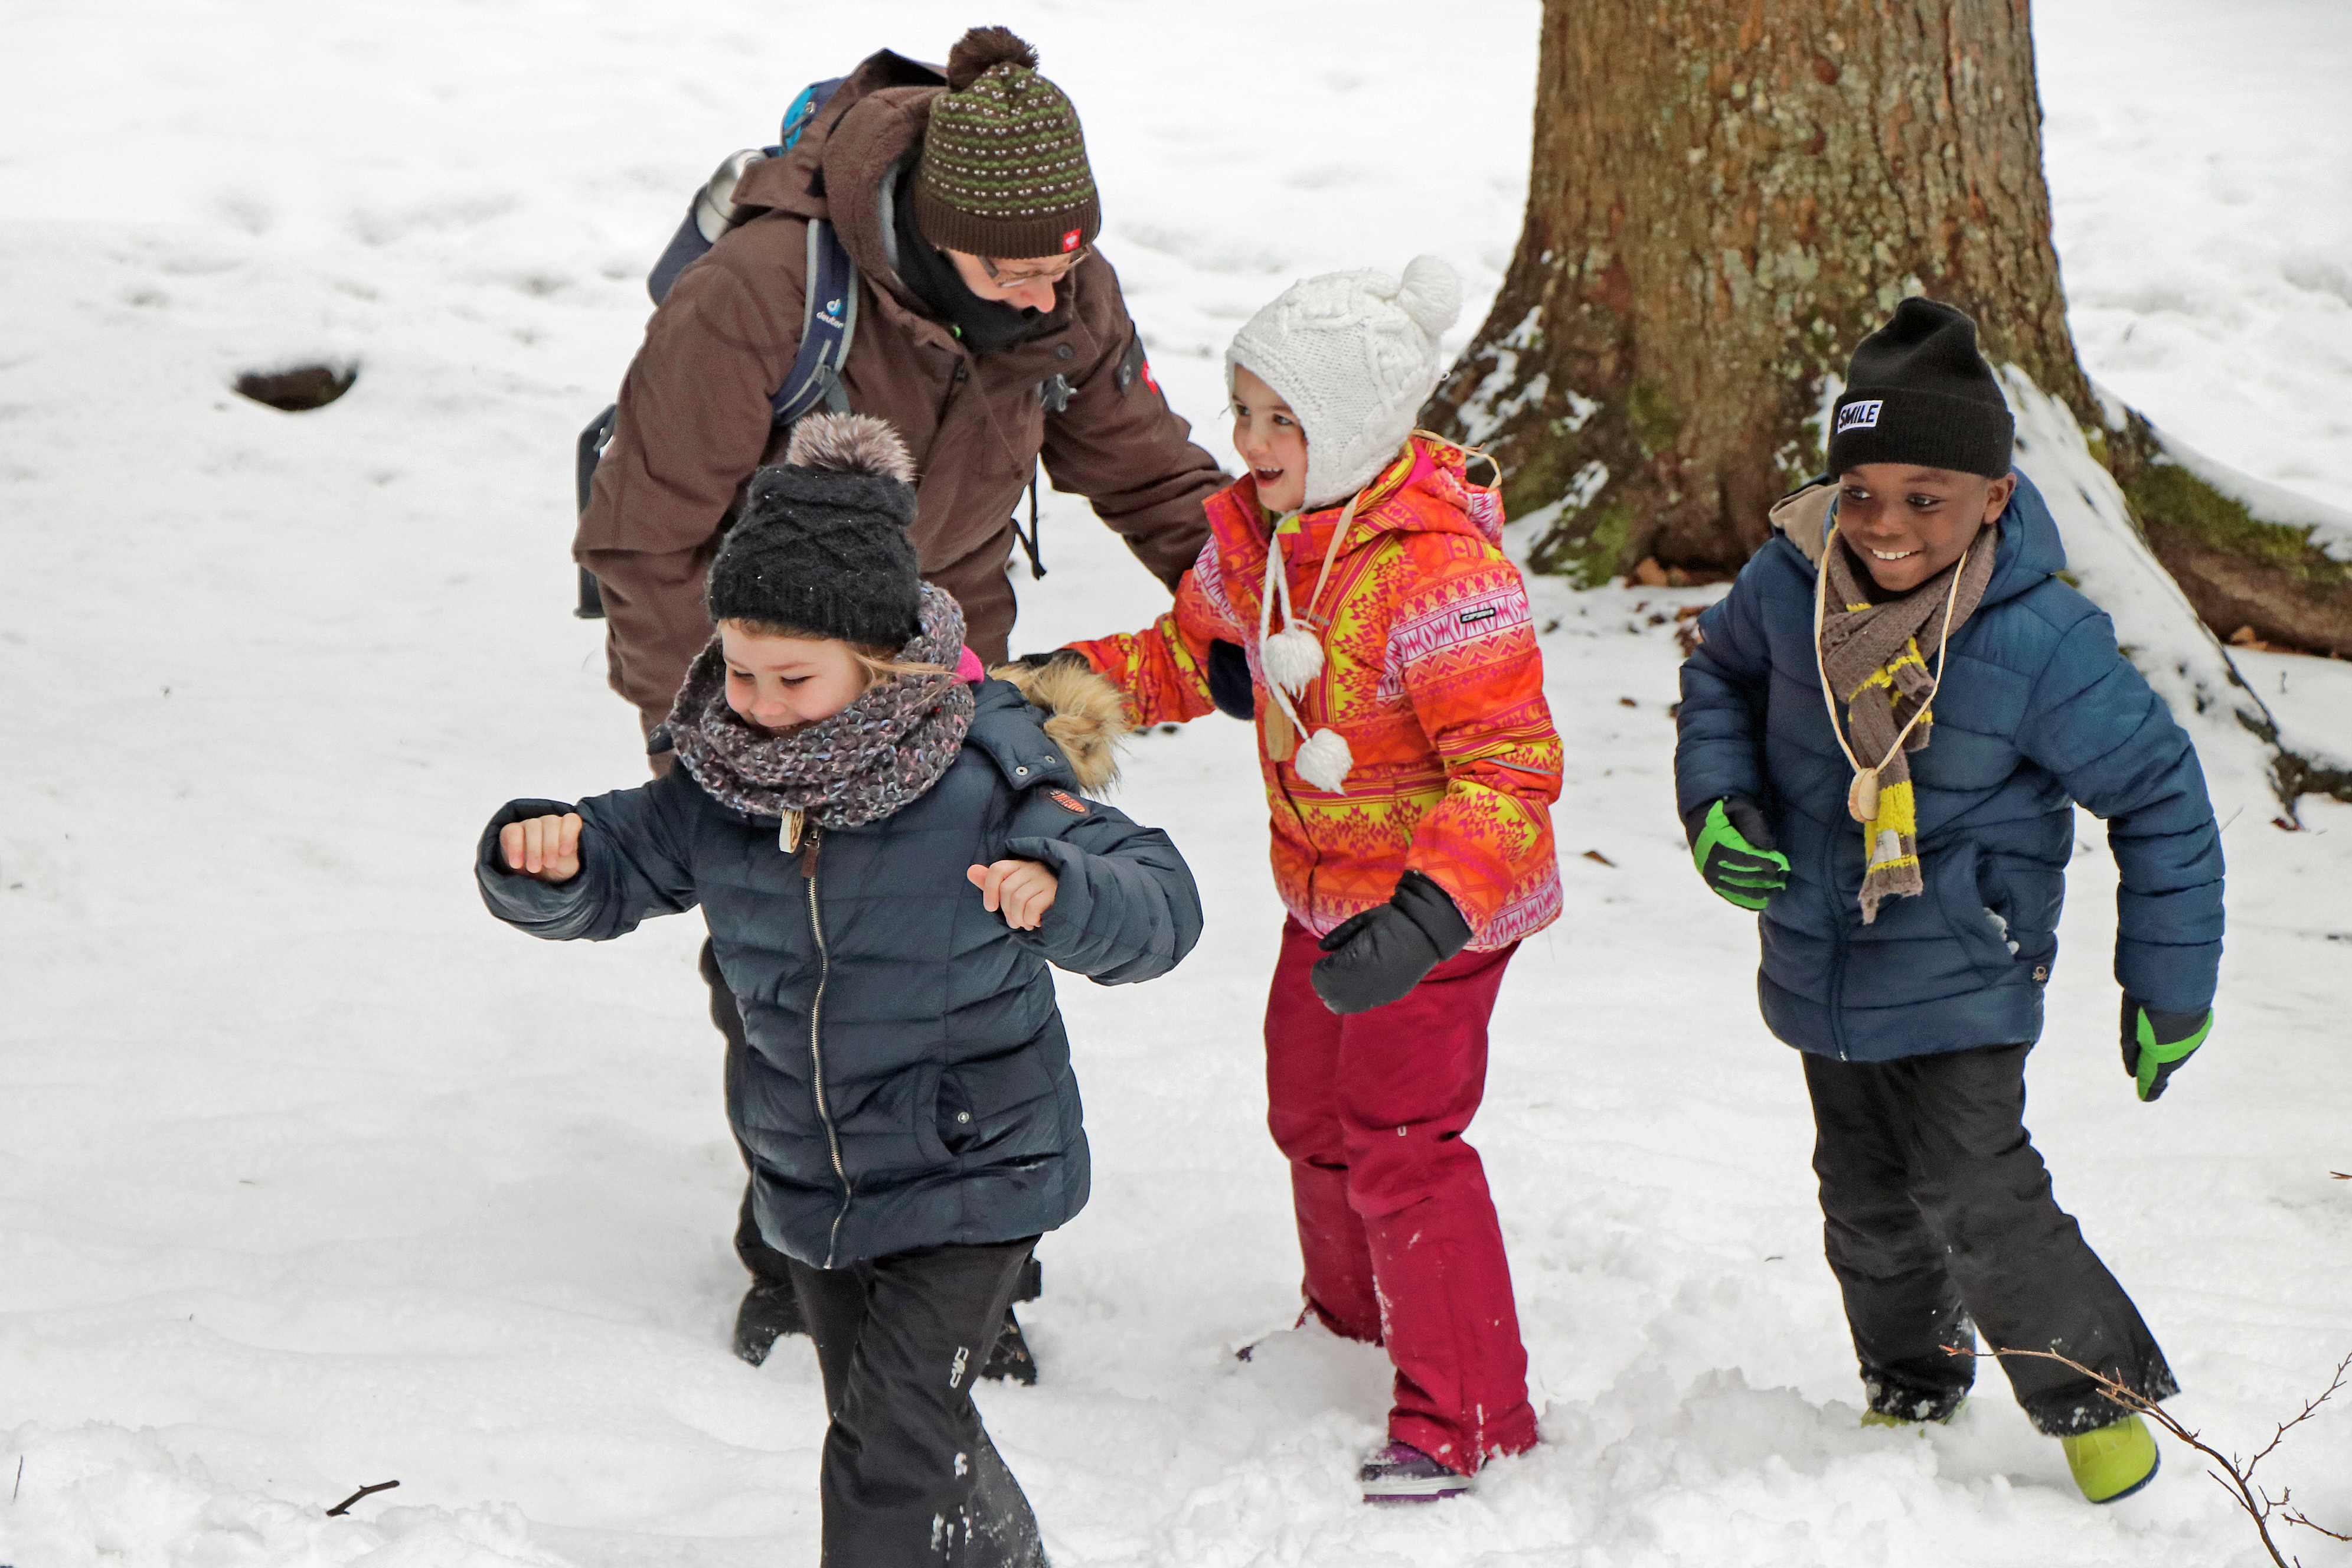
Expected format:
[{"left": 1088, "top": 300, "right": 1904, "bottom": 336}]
[{"left": 1073, "top": 437, "right": 1562, "bottom": 950}]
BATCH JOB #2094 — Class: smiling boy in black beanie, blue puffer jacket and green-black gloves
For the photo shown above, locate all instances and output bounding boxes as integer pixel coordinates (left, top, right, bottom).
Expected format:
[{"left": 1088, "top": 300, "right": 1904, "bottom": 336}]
[{"left": 1675, "top": 299, "right": 2223, "bottom": 1502}]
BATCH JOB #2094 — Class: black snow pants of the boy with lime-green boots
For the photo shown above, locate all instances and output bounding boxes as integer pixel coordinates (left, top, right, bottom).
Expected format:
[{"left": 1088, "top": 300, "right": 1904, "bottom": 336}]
[{"left": 1802, "top": 1046, "right": 2180, "bottom": 1436}]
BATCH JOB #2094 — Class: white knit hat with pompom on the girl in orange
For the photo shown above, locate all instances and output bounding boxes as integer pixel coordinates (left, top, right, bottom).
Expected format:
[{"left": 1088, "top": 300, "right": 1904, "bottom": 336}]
[{"left": 1226, "top": 256, "right": 1463, "bottom": 510}]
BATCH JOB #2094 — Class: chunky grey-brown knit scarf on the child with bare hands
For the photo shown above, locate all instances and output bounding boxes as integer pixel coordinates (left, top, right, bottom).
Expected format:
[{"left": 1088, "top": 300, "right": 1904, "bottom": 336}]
[{"left": 670, "top": 583, "right": 974, "bottom": 832}]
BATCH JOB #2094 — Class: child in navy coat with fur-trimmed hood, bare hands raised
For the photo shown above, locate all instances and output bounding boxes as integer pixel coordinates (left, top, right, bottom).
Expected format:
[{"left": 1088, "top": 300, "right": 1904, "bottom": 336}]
[{"left": 475, "top": 414, "right": 1200, "bottom": 1568}]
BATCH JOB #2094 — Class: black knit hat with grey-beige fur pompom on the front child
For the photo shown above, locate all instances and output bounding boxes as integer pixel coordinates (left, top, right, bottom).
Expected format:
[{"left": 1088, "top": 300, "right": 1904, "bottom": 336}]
[{"left": 703, "top": 414, "right": 922, "bottom": 651}]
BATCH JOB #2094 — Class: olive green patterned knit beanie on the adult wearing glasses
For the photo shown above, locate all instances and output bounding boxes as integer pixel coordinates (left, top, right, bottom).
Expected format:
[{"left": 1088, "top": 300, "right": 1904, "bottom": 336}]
[{"left": 915, "top": 28, "right": 1103, "bottom": 261}]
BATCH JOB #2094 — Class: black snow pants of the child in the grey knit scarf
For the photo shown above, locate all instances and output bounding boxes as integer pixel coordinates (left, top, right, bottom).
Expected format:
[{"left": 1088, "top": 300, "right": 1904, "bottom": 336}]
[{"left": 786, "top": 1237, "right": 1044, "bottom": 1568}]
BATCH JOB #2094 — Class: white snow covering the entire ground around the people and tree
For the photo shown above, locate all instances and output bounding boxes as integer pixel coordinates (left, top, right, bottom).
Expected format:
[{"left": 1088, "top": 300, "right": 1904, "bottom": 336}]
[{"left": 0, "top": 0, "right": 2352, "bottom": 1568}]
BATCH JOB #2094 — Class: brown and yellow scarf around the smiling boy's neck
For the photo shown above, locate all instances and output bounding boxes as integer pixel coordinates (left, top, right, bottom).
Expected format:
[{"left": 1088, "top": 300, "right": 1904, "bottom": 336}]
[{"left": 1821, "top": 524, "right": 1999, "bottom": 926}]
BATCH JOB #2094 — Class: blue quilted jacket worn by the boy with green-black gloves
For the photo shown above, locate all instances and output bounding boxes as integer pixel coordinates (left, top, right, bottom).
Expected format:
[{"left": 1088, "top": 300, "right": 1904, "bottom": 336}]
[{"left": 1675, "top": 475, "right": 2223, "bottom": 1063}]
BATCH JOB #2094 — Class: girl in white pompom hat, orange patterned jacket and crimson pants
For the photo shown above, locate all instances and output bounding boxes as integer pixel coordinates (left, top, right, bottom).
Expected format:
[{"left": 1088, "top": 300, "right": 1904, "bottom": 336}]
[{"left": 1063, "top": 256, "right": 1562, "bottom": 1502}]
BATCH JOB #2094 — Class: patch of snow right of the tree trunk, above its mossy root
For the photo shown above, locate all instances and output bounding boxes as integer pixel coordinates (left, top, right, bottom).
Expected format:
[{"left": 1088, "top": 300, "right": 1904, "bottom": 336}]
[{"left": 2034, "top": 0, "right": 2352, "bottom": 526}]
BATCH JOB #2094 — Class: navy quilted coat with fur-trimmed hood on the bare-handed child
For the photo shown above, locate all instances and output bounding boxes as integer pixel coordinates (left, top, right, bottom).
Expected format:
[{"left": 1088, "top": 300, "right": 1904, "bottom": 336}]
[{"left": 475, "top": 682, "right": 1200, "bottom": 1267}]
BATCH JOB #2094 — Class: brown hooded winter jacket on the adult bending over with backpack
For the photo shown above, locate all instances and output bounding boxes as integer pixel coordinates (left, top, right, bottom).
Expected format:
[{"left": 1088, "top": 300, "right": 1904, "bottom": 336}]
[{"left": 571, "top": 52, "right": 1226, "bottom": 729}]
